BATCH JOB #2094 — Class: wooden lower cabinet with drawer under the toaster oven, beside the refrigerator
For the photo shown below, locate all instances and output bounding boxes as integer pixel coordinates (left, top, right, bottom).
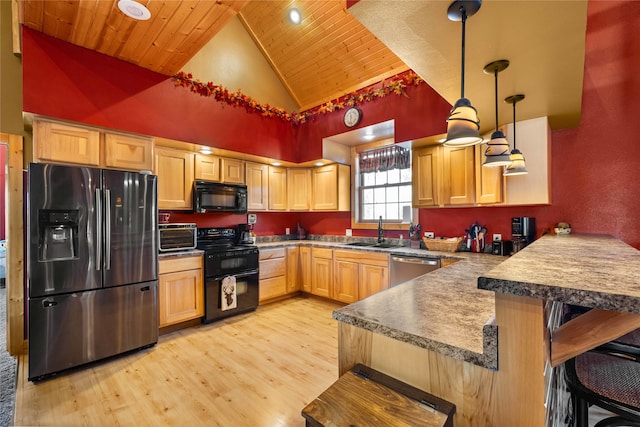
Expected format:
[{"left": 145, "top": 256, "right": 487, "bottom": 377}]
[{"left": 158, "top": 256, "right": 204, "bottom": 327}]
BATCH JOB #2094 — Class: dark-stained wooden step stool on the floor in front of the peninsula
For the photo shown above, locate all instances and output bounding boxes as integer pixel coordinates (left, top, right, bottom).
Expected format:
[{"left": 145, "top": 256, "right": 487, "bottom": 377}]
[{"left": 302, "top": 364, "right": 456, "bottom": 427}]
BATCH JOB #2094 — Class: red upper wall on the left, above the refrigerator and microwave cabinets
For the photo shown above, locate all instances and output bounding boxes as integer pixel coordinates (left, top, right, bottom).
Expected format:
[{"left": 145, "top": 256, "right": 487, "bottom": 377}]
[{"left": 22, "top": 27, "right": 297, "bottom": 161}]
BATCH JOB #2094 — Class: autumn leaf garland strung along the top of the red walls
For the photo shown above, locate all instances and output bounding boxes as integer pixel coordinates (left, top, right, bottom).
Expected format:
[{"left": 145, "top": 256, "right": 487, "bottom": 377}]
[{"left": 173, "top": 71, "right": 424, "bottom": 125}]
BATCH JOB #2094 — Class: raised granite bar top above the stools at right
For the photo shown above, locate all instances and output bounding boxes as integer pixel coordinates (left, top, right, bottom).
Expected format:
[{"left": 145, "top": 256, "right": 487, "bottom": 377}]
[{"left": 478, "top": 234, "right": 640, "bottom": 314}]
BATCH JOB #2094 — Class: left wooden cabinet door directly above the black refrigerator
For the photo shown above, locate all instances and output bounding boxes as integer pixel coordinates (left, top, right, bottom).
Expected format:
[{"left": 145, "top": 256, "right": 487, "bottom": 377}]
[{"left": 33, "top": 120, "right": 100, "bottom": 167}]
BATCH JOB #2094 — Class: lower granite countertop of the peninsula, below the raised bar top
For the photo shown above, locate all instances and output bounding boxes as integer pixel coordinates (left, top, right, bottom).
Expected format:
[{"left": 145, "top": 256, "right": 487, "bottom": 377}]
[{"left": 333, "top": 253, "right": 504, "bottom": 369}]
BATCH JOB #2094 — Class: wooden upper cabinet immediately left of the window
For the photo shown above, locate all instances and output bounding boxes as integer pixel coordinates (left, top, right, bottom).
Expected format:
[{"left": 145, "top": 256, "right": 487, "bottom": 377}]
[{"left": 312, "top": 164, "right": 351, "bottom": 211}]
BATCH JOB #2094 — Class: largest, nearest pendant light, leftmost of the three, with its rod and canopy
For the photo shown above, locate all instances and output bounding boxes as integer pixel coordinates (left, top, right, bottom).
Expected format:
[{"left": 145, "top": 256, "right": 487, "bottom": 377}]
[{"left": 443, "top": 0, "right": 482, "bottom": 147}]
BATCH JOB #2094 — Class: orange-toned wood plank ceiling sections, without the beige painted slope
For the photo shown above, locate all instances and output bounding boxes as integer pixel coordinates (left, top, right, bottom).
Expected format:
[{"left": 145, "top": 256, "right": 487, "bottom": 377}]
[{"left": 19, "top": 0, "right": 408, "bottom": 110}]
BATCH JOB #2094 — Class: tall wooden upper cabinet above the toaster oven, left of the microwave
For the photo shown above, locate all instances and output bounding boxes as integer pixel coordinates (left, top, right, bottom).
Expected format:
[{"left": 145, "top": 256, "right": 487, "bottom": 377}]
[{"left": 154, "top": 148, "right": 195, "bottom": 210}]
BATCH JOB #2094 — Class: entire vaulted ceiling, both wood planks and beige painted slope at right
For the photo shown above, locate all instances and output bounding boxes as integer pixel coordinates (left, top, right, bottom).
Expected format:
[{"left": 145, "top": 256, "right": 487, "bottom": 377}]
[{"left": 18, "top": 0, "right": 587, "bottom": 131}]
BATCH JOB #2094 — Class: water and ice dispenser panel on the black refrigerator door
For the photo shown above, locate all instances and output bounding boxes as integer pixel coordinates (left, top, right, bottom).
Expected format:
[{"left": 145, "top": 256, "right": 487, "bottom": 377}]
[{"left": 38, "top": 209, "right": 79, "bottom": 262}]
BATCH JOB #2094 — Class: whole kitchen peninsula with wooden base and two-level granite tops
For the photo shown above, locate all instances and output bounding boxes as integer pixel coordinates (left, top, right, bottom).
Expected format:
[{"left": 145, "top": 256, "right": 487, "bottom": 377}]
[{"left": 334, "top": 235, "right": 640, "bottom": 426}]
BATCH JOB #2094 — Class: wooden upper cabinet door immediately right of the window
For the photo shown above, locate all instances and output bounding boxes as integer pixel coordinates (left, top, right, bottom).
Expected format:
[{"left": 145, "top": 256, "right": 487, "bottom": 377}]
[{"left": 412, "top": 146, "right": 441, "bottom": 207}]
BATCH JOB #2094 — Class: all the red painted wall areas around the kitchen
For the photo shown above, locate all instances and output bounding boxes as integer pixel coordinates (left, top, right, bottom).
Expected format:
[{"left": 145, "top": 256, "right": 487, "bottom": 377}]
[{"left": 18, "top": 0, "right": 640, "bottom": 248}]
